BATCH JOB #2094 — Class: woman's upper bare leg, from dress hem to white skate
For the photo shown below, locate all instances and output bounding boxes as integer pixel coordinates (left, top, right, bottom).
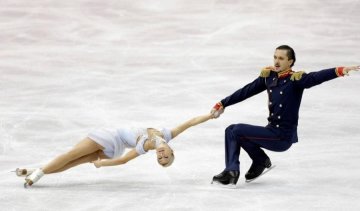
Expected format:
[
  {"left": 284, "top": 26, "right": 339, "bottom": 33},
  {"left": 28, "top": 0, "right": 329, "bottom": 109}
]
[{"left": 42, "top": 138, "right": 104, "bottom": 174}]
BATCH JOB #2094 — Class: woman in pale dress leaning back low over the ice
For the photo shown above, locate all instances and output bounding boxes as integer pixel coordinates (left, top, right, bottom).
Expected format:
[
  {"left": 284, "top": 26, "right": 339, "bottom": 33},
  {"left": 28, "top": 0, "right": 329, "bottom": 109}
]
[{"left": 16, "top": 114, "right": 214, "bottom": 188}]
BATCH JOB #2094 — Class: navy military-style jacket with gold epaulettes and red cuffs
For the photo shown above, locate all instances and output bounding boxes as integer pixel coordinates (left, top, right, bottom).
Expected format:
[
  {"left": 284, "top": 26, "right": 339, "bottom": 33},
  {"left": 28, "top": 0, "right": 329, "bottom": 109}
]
[{"left": 221, "top": 68, "right": 342, "bottom": 143}]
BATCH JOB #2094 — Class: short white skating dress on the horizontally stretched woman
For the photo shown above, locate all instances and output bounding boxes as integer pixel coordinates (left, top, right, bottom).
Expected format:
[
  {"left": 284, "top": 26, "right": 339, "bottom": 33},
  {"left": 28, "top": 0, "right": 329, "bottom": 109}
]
[{"left": 88, "top": 128, "right": 172, "bottom": 158}]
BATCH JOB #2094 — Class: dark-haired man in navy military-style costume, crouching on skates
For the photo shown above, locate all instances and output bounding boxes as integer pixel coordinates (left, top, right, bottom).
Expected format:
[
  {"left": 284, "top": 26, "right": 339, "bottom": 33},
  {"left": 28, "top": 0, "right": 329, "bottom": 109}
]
[{"left": 211, "top": 45, "right": 360, "bottom": 186}]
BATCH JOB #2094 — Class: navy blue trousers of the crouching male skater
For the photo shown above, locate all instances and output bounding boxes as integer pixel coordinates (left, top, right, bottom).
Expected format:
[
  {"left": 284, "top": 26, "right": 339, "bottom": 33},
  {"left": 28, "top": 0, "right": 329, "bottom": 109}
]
[{"left": 225, "top": 124, "right": 292, "bottom": 171}]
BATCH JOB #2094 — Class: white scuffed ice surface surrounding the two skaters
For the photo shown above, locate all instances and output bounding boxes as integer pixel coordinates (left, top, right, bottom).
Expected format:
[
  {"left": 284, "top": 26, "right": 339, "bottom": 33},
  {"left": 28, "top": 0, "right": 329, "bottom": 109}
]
[{"left": 0, "top": 0, "right": 360, "bottom": 211}]
